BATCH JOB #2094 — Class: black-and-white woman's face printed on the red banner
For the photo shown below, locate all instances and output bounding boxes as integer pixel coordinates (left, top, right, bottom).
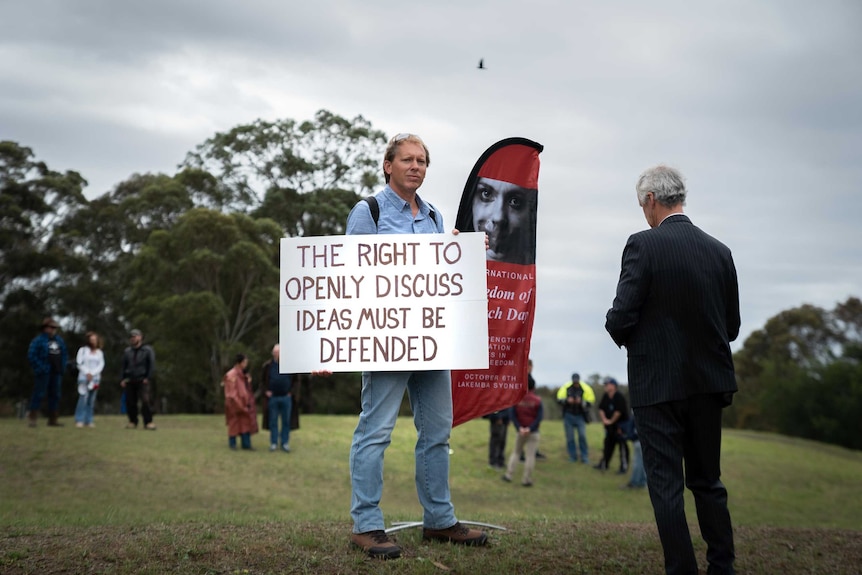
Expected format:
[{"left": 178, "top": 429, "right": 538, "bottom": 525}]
[{"left": 473, "top": 178, "right": 535, "bottom": 263}]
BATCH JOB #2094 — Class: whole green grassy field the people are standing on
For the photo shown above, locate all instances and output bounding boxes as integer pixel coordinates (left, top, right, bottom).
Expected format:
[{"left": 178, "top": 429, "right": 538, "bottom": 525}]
[{"left": 0, "top": 416, "right": 862, "bottom": 574}]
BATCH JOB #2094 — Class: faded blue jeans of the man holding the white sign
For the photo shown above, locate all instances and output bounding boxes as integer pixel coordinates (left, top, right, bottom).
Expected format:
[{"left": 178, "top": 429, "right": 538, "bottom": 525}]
[{"left": 350, "top": 370, "right": 458, "bottom": 533}]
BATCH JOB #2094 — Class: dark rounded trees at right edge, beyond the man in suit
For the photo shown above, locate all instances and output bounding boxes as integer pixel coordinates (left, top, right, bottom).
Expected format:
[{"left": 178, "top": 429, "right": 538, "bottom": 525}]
[{"left": 725, "top": 297, "right": 862, "bottom": 449}]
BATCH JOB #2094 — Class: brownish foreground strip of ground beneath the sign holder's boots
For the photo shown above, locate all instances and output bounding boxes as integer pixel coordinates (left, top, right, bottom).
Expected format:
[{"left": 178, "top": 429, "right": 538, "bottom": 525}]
[{"left": 0, "top": 521, "right": 862, "bottom": 575}]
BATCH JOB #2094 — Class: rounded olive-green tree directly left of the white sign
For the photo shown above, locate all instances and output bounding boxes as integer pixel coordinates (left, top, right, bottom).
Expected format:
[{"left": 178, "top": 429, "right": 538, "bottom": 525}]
[{"left": 128, "top": 208, "right": 282, "bottom": 412}]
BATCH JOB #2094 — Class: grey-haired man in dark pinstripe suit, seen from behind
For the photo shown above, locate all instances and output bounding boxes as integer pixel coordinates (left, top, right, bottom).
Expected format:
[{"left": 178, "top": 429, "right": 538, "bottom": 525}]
[{"left": 605, "top": 166, "right": 740, "bottom": 574}]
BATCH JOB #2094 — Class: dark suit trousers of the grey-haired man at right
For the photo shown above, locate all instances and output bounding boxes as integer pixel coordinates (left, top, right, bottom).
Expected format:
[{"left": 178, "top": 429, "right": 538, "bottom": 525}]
[{"left": 634, "top": 394, "right": 735, "bottom": 575}]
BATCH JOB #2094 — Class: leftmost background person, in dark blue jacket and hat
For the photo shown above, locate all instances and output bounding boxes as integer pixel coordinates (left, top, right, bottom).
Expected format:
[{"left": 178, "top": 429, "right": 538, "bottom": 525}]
[{"left": 27, "top": 317, "right": 67, "bottom": 427}]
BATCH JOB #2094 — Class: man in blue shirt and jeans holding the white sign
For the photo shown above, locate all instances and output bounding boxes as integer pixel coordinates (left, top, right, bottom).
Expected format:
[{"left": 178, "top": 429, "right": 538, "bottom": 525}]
[{"left": 347, "top": 134, "right": 487, "bottom": 559}]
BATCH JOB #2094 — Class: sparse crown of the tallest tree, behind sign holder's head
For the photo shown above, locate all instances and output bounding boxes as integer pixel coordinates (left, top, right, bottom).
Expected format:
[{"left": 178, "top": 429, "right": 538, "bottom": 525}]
[{"left": 184, "top": 110, "right": 386, "bottom": 236}]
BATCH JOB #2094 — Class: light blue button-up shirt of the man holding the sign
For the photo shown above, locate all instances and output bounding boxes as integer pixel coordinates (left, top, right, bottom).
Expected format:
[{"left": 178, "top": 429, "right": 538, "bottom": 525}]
[{"left": 345, "top": 185, "right": 444, "bottom": 235}]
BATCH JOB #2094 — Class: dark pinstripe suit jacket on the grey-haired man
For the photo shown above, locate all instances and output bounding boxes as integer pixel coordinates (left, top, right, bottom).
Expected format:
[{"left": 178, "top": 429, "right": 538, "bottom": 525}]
[{"left": 605, "top": 215, "right": 740, "bottom": 407}]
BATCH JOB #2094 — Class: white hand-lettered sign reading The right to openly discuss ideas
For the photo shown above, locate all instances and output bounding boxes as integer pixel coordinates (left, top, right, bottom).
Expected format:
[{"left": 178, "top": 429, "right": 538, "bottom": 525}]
[{"left": 279, "top": 232, "right": 488, "bottom": 373}]
